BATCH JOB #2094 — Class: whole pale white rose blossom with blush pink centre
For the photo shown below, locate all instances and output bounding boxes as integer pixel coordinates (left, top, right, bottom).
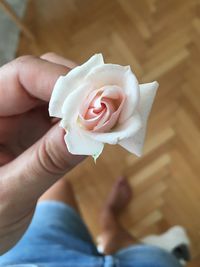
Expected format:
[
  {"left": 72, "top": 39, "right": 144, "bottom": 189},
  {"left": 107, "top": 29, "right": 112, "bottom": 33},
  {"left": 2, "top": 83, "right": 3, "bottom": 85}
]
[{"left": 49, "top": 54, "right": 158, "bottom": 159}]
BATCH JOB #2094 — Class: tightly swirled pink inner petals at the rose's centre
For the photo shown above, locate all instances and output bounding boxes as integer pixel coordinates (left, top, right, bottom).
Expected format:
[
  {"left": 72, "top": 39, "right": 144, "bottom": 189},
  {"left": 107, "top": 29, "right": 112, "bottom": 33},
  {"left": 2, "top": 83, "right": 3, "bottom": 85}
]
[{"left": 79, "top": 86, "right": 125, "bottom": 132}]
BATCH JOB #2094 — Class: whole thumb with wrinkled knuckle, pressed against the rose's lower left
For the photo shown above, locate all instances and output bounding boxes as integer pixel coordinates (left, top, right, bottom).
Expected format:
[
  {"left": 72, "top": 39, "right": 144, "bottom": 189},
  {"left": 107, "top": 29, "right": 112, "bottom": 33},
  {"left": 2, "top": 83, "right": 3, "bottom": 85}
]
[{"left": 0, "top": 123, "right": 85, "bottom": 207}]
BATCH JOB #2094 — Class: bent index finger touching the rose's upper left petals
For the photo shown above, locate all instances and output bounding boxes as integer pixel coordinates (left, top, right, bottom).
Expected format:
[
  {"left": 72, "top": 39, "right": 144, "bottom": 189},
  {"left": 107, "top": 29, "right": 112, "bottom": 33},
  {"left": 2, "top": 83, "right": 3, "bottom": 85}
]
[{"left": 0, "top": 56, "right": 70, "bottom": 116}]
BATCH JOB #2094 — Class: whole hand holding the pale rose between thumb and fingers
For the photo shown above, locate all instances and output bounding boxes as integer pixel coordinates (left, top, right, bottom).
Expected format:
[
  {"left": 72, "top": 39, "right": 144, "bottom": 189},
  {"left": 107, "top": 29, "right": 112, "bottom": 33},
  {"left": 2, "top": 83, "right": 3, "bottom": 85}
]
[{"left": 0, "top": 54, "right": 83, "bottom": 254}]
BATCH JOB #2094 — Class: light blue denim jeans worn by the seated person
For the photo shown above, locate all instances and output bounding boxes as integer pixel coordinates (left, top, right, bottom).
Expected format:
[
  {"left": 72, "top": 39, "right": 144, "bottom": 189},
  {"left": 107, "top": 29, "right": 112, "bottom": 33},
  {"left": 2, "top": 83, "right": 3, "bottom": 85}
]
[{"left": 0, "top": 201, "right": 180, "bottom": 267}]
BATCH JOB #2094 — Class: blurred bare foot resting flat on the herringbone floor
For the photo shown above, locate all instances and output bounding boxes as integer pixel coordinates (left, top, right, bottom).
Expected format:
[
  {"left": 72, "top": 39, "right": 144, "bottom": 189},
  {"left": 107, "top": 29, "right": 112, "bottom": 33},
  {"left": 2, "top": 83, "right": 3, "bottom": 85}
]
[{"left": 104, "top": 176, "right": 132, "bottom": 215}]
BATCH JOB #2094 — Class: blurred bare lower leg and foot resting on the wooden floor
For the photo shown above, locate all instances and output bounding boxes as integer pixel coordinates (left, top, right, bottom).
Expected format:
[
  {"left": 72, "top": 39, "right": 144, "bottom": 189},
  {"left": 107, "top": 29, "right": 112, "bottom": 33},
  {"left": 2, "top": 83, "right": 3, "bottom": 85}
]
[{"left": 99, "top": 177, "right": 138, "bottom": 254}]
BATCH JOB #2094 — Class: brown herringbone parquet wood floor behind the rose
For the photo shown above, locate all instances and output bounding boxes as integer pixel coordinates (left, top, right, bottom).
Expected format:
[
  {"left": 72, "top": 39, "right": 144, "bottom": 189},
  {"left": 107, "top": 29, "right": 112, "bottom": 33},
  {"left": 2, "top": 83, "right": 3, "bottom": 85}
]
[{"left": 18, "top": 0, "right": 200, "bottom": 266}]
